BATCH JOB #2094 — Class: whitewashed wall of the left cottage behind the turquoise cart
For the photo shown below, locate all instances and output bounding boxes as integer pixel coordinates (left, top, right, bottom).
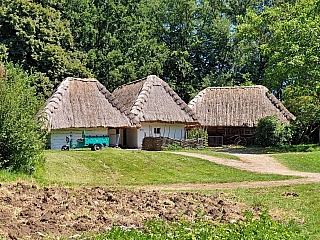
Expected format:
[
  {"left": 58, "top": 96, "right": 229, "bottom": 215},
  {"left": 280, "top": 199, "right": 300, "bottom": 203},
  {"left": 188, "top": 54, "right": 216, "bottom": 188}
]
[{"left": 50, "top": 128, "right": 108, "bottom": 149}]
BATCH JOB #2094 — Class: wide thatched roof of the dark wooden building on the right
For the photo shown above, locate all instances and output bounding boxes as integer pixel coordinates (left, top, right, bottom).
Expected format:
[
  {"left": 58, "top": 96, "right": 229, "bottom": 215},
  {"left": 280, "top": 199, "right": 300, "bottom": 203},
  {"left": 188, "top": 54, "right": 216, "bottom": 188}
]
[{"left": 188, "top": 85, "right": 295, "bottom": 127}]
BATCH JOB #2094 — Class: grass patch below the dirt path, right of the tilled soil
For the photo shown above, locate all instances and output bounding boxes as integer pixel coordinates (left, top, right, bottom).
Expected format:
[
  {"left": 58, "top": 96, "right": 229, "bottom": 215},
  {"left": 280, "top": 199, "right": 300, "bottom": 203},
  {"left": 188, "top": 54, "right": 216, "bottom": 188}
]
[{"left": 224, "top": 183, "right": 320, "bottom": 240}]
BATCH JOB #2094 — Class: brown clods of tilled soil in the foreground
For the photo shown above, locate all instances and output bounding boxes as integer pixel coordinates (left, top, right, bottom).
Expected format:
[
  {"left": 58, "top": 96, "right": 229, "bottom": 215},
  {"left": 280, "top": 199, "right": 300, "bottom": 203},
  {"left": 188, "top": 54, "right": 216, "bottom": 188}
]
[{"left": 0, "top": 183, "right": 243, "bottom": 239}]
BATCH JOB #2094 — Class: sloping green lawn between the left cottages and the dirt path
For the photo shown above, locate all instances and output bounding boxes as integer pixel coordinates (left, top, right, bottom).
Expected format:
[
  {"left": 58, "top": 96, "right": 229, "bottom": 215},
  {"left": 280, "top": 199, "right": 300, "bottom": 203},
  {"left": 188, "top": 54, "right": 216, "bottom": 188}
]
[{"left": 28, "top": 148, "right": 293, "bottom": 186}]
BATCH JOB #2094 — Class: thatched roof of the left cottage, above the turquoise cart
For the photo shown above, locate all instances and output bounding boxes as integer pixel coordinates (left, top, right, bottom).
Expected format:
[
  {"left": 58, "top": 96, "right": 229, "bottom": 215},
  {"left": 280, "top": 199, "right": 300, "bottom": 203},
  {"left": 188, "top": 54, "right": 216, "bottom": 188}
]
[{"left": 40, "top": 77, "right": 134, "bottom": 131}]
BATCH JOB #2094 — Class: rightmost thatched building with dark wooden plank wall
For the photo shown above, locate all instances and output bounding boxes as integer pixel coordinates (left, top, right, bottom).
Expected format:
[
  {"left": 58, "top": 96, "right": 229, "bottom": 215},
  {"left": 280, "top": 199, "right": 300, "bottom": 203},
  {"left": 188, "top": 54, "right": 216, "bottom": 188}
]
[{"left": 188, "top": 85, "right": 295, "bottom": 146}]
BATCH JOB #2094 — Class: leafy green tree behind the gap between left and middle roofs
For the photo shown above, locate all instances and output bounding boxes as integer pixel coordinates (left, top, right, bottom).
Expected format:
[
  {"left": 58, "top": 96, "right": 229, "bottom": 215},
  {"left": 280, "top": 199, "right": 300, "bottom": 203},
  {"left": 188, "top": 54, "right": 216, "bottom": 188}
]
[{"left": 57, "top": 0, "right": 167, "bottom": 91}]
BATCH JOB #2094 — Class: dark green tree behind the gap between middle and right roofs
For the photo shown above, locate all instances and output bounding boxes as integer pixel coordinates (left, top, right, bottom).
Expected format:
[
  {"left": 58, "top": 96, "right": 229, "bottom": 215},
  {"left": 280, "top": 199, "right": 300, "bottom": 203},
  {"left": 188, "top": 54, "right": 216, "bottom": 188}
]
[{"left": 145, "top": 0, "right": 233, "bottom": 101}]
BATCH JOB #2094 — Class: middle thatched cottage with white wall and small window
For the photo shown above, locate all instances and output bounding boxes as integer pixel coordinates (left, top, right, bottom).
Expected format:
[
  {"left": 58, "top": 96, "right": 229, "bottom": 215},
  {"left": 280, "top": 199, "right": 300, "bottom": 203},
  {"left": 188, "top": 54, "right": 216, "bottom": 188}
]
[{"left": 112, "top": 75, "right": 198, "bottom": 148}]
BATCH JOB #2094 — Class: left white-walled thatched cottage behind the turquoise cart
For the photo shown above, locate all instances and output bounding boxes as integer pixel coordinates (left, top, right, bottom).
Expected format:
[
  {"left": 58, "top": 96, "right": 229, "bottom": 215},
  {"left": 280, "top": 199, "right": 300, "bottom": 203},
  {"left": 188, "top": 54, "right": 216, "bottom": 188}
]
[{"left": 39, "top": 77, "right": 137, "bottom": 149}]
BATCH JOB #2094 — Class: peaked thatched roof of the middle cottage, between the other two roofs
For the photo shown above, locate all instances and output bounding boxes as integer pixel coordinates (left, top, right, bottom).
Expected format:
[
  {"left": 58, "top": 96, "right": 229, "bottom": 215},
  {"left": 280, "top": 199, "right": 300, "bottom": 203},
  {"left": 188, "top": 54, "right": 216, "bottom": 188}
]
[{"left": 112, "top": 75, "right": 198, "bottom": 124}]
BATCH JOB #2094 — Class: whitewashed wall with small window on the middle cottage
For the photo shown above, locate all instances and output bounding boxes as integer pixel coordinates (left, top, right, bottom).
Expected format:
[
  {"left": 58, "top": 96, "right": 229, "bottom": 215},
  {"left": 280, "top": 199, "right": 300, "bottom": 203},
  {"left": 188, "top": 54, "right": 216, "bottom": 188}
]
[{"left": 136, "top": 123, "right": 186, "bottom": 148}]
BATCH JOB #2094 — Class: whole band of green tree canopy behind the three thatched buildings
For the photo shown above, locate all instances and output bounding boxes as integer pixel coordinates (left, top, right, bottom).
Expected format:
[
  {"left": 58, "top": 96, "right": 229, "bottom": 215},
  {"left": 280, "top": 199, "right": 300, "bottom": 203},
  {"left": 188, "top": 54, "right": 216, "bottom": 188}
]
[{"left": 0, "top": 0, "right": 320, "bottom": 145}]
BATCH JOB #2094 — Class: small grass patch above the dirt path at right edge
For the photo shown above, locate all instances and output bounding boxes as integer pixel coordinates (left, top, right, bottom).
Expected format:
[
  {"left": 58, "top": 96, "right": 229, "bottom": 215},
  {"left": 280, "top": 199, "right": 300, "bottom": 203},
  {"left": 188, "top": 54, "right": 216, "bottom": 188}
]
[{"left": 272, "top": 152, "right": 320, "bottom": 173}]
